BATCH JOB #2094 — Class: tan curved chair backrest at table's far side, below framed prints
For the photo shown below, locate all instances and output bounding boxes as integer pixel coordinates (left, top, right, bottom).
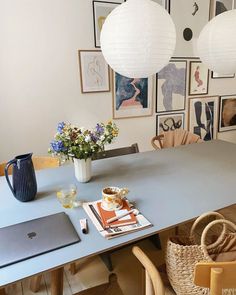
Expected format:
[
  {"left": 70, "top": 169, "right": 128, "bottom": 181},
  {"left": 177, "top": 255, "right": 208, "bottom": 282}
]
[{"left": 151, "top": 129, "right": 202, "bottom": 149}]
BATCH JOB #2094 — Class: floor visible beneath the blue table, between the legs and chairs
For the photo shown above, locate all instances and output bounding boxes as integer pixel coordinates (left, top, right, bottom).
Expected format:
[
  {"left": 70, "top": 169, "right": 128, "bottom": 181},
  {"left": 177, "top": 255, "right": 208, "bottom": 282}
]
[{"left": 3, "top": 205, "right": 236, "bottom": 295}]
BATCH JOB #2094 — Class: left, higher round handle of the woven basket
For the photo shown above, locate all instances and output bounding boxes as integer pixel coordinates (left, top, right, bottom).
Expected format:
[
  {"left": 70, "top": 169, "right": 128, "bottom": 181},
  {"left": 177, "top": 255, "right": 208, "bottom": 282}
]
[{"left": 189, "top": 211, "right": 226, "bottom": 249}]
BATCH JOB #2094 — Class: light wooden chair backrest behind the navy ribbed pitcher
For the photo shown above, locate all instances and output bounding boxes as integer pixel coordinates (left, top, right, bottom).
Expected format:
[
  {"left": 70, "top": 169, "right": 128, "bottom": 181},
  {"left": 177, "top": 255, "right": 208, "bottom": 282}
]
[{"left": 0, "top": 156, "right": 60, "bottom": 176}]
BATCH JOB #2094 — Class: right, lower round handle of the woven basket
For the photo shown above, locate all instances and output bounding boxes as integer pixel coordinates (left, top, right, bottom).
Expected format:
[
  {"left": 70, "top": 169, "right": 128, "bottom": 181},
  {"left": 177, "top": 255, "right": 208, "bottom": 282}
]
[{"left": 201, "top": 219, "right": 236, "bottom": 256}]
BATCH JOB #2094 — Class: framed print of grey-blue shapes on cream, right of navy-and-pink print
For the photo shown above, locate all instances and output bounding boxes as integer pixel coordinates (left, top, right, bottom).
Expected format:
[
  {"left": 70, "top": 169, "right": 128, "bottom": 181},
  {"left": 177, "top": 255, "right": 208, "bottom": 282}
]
[{"left": 156, "top": 60, "right": 187, "bottom": 113}]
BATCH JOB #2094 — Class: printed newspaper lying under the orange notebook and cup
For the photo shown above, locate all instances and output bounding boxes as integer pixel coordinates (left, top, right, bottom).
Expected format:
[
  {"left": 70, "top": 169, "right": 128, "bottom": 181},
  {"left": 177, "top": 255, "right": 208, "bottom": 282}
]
[{"left": 83, "top": 200, "right": 152, "bottom": 239}]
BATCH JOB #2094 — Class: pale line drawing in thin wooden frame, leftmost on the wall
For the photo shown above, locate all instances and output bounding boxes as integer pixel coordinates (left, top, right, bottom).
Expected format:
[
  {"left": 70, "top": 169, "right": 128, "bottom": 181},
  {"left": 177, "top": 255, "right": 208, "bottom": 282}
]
[{"left": 78, "top": 50, "right": 110, "bottom": 93}]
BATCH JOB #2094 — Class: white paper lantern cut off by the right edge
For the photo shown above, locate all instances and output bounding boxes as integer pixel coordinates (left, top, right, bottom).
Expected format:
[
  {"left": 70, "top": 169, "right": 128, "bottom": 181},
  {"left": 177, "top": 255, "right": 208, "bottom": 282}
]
[{"left": 198, "top": 10, "right": 236, "bottom": 74}]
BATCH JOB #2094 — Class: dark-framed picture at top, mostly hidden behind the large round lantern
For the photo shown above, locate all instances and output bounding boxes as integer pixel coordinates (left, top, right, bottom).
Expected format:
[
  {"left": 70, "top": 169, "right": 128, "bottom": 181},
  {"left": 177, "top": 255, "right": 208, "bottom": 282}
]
[{"left": 93, "top": 1, "right": 122, "bottom": 48}]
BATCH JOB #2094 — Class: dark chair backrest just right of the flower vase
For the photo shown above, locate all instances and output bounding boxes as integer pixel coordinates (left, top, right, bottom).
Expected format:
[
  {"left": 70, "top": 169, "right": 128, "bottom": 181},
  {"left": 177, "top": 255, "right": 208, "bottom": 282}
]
[{"left": 93, "top": 143, "right": 139, "bottom": 160}]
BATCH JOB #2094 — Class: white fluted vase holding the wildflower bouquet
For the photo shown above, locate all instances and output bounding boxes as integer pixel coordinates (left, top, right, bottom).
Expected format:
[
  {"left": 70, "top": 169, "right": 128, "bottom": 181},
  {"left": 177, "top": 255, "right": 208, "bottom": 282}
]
[{"left": 74, "top": 158, "right": 92, "bottom": 182}]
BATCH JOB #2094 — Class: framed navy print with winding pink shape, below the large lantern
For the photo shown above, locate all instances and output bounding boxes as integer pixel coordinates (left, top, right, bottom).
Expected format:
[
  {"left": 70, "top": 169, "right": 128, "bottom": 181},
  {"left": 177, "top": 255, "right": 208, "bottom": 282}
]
[{"left": 113, "top": 72, "right": 153, "bottom": 119}]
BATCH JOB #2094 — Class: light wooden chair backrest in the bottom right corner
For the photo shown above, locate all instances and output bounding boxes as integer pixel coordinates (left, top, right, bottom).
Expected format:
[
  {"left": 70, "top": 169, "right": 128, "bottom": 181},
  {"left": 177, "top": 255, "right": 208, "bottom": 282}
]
[{"left": 194, "top": 261, "right": 236, "bottom": 295}]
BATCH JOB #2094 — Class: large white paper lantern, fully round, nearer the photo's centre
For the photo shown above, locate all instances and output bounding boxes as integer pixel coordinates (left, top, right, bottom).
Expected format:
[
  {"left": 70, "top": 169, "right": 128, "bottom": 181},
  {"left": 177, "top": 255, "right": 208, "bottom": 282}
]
[{"left": 100, "top": 0, "right": 176, "bottom": 78}]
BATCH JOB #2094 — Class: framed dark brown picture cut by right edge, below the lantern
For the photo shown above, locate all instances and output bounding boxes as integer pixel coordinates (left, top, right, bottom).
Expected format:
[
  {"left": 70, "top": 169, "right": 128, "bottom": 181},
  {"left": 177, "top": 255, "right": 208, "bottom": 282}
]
[{"left": 219, "top": 95, "right": 236, "bottom": 132}]
